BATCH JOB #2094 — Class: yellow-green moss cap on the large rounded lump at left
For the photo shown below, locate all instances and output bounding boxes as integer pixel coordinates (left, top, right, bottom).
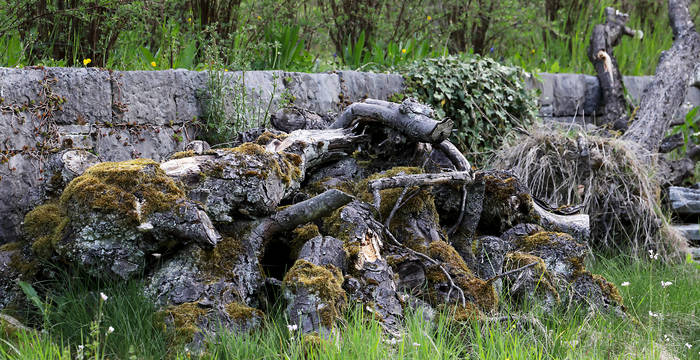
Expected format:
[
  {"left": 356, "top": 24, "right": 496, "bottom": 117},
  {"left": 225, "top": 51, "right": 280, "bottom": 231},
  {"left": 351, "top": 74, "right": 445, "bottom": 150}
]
[{"left": 60, "top": 159, "right": 185, "bottom": 222}]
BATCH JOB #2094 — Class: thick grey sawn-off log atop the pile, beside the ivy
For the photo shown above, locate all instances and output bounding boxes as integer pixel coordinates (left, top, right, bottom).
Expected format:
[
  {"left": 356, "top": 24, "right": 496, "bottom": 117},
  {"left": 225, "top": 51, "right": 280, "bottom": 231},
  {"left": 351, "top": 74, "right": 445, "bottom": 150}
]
[{"left": 330, "top": 99, "right": 453, "bottom": 144}]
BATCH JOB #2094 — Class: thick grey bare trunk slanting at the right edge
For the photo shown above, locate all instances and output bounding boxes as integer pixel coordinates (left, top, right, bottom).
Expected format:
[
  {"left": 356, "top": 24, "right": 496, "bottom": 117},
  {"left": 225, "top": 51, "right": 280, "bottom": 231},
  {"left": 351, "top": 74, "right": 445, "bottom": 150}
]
[{"left": 622, "top": 0, "right": 700, "bottom": 153}]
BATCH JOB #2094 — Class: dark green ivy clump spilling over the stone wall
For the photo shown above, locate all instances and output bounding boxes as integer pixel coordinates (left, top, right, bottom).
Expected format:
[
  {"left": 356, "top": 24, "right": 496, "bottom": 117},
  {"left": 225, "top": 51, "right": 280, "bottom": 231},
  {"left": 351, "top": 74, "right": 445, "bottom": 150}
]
[{"left": 403, "top": 56, "right": 537, "bottom": 164}]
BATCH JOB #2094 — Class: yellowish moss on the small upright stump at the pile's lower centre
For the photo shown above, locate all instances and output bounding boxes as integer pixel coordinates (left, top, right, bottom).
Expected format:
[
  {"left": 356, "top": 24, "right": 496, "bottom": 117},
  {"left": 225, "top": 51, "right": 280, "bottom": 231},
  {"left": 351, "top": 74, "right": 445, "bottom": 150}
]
[{"left": 284, "top": 259, "right": 346, "bottom": 328}]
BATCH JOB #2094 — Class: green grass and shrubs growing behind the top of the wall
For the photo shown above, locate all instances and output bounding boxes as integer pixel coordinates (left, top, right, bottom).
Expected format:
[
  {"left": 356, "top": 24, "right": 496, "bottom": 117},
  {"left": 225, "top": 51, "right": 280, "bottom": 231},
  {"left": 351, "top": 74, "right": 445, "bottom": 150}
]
[{"left": 0, "top": 0, "right": 700, "bottom": 75}]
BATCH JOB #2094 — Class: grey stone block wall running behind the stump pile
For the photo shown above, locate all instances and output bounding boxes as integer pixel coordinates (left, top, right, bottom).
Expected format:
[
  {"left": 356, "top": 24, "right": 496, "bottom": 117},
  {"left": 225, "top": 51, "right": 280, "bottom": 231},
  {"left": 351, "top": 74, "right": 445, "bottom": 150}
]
[{"left": 0, "top": 67, "right": 700, "bottom": 244}]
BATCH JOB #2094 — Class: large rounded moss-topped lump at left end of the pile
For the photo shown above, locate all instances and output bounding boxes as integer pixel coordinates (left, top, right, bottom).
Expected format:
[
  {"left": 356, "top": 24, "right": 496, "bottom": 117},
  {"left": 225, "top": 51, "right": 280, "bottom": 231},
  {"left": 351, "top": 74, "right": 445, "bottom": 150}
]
[{"left": 44, "top": 160, "right": 220, "bottom": 279}]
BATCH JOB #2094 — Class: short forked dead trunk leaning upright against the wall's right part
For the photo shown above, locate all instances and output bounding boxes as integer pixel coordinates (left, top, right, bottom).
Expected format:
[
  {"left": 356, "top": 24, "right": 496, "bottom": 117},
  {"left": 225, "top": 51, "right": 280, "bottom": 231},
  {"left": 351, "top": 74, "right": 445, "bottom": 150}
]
[{"left": 588, "top": 7, "right": 641, "bottom": 130}]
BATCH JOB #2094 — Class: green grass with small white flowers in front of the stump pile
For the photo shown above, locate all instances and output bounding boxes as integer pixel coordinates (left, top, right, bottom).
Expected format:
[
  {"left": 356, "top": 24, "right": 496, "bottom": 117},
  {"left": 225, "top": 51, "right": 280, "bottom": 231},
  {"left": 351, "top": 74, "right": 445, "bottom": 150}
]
[{"left": 0, "top": 257, "right": 700, "bottom": 360}]
